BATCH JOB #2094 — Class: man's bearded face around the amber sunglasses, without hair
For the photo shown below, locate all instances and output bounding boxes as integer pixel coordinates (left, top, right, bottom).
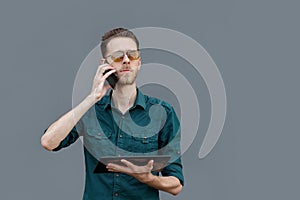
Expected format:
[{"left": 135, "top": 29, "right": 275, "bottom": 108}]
[{"left": 106, "top": 37, "right": 141, "bottom": 85}]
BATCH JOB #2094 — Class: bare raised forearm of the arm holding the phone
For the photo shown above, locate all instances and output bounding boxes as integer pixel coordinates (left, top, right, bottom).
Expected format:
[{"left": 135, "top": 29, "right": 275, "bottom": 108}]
[{"left": 41, "top": 95, "right": 95, "bottom": 151}]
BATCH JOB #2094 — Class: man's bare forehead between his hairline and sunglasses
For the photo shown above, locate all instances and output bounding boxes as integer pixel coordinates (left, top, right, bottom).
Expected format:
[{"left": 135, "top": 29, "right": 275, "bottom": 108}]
[{"left": 106, "top": 37, "right": 137, "bottom": 55}]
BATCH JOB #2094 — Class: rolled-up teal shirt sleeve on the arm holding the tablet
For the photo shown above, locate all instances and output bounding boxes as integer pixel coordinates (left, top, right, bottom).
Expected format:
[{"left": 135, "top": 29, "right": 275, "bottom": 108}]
[{"left": 159, "top": 107, "right": 184, "bottom": 185}]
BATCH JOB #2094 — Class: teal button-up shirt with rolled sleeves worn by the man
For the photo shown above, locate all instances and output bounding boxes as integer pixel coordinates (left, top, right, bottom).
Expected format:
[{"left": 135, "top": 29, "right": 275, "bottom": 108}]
[{"left": 53, "top": 89, "right": 184, "bottom": 200}]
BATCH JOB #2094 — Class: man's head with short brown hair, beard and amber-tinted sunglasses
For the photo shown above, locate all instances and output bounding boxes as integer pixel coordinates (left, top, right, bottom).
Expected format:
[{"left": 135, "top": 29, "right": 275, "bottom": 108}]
[{"left": 101, "top": 28, "right": 141, "bottom": 85}]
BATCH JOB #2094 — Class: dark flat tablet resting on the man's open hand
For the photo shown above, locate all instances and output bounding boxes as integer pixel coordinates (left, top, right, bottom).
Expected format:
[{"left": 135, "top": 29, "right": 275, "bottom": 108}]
[{"left": 94, "top": 155, "right": 171, "bottom": 173}]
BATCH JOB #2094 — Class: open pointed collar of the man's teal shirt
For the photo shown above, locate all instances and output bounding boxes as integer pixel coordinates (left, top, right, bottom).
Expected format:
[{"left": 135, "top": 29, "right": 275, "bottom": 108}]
[{"left": 97, "top": 88, "right": 146, "bottom": 110}]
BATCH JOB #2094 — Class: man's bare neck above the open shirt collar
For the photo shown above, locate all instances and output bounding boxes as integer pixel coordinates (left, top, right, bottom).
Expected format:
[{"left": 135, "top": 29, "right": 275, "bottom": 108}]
[{"left": 112, "top": 84, "right": 137, "bottom": 114}]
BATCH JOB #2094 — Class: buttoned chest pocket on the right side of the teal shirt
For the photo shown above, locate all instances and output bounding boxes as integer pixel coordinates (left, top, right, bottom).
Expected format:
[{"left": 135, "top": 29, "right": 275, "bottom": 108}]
[{"left": 131, "top": 133, "right": 158, "bottom": 154}]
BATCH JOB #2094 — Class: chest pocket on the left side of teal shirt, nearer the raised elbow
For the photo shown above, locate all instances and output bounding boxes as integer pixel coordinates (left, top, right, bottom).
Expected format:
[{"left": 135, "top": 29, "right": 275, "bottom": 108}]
[{"left": 83, "top": 129, "right": 115, "bottom": 159}]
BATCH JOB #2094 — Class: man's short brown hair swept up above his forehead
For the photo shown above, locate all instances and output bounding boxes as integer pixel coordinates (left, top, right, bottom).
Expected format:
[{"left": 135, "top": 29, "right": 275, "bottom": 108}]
[{"left": 100, "top": 28, "right": 139, "bottom": 57}]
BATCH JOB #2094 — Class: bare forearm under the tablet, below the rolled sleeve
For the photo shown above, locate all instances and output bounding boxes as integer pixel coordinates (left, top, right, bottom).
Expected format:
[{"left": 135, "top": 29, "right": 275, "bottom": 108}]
[{"left": 141, "top": 173, "right": 182, "bottom": 195}]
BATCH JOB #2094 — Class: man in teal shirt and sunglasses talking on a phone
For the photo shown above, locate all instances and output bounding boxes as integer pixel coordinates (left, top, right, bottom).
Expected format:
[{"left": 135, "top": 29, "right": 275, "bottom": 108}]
[{"left": 41, "top": 28, "right": 183, "bottom": 200}]
